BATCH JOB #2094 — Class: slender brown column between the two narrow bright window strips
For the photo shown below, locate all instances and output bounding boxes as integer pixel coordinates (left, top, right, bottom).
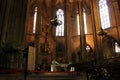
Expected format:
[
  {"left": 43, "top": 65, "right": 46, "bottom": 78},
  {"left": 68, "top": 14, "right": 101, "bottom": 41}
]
[{"left": 78, "top": 1, "right": 86, "bottom": 62}]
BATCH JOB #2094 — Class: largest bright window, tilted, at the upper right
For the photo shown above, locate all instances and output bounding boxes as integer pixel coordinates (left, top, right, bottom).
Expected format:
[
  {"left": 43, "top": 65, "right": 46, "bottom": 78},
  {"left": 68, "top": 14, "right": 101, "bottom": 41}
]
[{"left": 99, "top": 0, "right": 110, "bottom": 29}]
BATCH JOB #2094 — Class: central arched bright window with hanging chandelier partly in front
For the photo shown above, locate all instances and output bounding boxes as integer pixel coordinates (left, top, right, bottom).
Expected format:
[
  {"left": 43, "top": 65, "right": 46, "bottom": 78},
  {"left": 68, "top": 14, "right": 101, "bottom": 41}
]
[{"left": 56, "top": 9, "right": 64, "bottom": 36}]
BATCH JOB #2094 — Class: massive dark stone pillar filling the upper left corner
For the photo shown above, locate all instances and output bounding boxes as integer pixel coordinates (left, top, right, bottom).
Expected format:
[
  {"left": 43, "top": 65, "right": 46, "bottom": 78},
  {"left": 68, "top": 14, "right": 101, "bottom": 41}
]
[{"left": 0, "top": 0, "right": 27, "bottom": 44}]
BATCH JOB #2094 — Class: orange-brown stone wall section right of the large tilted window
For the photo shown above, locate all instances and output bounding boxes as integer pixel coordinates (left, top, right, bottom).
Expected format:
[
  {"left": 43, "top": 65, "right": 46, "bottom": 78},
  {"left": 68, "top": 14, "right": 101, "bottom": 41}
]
[{"left": 108, "top": 0, "right": 120, "bottom": 41}]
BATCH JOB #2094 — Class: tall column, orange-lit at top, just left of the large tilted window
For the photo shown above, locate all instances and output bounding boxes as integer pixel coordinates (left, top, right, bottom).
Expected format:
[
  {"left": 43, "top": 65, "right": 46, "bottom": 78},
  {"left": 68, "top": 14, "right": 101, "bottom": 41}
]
[{"left": 91, "top": 0, "right": 100, "bottom": 64}]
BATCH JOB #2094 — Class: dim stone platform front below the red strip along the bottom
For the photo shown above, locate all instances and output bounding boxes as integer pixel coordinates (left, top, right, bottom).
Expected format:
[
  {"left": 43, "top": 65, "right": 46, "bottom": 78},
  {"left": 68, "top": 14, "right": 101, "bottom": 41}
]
[{"left": 0, "top": 72, "right": 87, "bottom": 80}]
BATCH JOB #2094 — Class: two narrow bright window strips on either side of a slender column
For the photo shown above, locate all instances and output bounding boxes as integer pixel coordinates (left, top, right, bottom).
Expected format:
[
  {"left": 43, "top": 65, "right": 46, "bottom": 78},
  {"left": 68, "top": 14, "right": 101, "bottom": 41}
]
[{"left": 77, "top": 12, "right": 87, "bottom": 35}]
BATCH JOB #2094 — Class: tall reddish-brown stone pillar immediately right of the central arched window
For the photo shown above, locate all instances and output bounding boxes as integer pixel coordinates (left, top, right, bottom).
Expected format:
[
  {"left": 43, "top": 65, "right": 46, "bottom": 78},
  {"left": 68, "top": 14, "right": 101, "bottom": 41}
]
[{"left": 64, "top": 1, "right": 72, "bottom": 62}]
